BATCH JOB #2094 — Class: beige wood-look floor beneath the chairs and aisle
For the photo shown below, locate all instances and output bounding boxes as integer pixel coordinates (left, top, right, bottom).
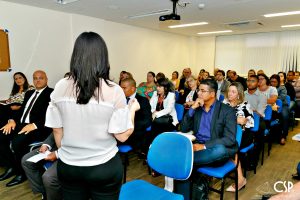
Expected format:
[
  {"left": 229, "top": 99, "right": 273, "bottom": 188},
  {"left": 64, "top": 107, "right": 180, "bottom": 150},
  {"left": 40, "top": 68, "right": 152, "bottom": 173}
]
[{"left": 0, "top": 125, "right": 300, "bottom": 200}]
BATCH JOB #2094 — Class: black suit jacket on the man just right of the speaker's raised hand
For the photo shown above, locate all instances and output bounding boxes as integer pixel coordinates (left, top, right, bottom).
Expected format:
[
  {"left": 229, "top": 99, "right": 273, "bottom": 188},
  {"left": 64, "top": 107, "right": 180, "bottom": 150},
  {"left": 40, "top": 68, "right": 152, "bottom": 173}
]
[{"left": 134, "top": 94, "right": 152, "bottom": 131}]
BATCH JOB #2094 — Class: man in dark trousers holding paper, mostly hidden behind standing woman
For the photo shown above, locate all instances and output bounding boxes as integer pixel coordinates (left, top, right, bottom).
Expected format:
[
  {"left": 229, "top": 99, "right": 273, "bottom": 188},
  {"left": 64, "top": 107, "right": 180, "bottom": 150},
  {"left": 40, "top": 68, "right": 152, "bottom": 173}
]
[{"left": 22, "top": 134, "right": 62, "bottom": 200}]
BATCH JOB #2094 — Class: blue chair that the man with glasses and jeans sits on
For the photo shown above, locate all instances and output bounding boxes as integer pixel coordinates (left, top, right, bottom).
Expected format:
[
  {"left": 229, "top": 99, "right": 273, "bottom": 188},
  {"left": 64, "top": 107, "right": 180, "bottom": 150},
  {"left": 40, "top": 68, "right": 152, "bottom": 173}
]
[{"left": 197, "top": 125, "right": 243, "bottom": 200}]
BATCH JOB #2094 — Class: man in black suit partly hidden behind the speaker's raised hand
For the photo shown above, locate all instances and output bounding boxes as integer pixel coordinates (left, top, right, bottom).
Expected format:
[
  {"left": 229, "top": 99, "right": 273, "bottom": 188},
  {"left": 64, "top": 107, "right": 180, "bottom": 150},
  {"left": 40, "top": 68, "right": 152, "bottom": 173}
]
[{"left": 121, "top": 78, "right": 152, "bottom": 153}]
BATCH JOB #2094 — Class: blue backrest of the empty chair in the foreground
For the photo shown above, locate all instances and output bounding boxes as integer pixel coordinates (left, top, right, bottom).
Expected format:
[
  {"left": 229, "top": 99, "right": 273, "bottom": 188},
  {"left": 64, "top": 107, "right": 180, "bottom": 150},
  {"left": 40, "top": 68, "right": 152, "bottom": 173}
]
[{"left": 147, "top": 132, "right": 194, "bottom": 180}]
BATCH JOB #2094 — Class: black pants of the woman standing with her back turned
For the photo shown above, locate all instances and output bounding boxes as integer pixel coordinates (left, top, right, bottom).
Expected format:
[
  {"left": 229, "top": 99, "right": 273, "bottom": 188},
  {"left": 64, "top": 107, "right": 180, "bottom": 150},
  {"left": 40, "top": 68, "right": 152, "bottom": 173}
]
[{"left": 57, "top": 154, "right": 123, "bottom": 200}]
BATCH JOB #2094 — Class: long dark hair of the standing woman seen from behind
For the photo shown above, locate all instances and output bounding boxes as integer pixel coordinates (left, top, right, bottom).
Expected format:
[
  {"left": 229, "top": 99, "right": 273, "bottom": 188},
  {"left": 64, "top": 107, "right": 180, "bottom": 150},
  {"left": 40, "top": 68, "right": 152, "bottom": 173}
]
[{"left": 70, "top": 32, "right": 112, "bottom": 104}]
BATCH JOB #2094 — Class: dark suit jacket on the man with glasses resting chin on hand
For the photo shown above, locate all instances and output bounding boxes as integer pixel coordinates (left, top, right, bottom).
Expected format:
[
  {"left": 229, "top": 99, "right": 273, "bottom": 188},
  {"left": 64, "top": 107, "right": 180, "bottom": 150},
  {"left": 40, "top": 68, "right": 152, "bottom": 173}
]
[{"left": 181, "top": 101, "right": 238, "bottom": 156}]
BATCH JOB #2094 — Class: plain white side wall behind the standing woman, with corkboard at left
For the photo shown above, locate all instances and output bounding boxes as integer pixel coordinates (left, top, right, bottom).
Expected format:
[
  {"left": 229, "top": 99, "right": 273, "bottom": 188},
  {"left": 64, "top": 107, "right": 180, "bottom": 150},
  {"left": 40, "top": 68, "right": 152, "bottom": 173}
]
[{"left": 0, "top": 1, "right": 215, "bottom": 99}]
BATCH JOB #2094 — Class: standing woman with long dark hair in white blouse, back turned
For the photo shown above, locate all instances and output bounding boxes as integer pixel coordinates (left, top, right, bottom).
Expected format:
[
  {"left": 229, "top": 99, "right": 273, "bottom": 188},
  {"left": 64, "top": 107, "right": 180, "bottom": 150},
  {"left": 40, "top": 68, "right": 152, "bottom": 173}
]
[{"left": 46, "top": 32, "right": 139, "bottom": 200}]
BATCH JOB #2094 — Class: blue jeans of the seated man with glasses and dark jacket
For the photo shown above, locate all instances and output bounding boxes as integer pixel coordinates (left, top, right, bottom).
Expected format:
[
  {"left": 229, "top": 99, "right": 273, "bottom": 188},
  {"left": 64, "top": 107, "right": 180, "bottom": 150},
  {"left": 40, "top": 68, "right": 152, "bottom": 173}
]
[{"left": 174, "top": 144, "right": 230, "bottom": 200}]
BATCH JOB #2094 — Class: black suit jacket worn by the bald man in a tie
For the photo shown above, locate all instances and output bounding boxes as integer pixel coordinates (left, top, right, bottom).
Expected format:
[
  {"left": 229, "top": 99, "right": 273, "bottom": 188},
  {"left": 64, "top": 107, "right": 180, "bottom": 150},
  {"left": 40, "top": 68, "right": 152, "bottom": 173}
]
[{"left": 13, "top": 86, "right": 53, "bottom": 129}]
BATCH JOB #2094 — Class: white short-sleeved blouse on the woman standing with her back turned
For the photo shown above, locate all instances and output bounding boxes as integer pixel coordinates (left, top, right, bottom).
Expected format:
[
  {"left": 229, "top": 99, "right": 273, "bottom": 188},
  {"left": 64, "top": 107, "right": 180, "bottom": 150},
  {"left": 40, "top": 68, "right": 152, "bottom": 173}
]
[{"left": 45, "top": 78, "right": 133, "bottom": 166}]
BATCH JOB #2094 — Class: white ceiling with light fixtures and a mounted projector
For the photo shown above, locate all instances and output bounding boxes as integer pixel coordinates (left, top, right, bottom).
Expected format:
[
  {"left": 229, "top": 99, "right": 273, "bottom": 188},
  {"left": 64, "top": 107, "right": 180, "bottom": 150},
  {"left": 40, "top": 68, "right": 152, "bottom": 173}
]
[{"left": 2, "top": 0, "right": 300, "bottom": 36}]
